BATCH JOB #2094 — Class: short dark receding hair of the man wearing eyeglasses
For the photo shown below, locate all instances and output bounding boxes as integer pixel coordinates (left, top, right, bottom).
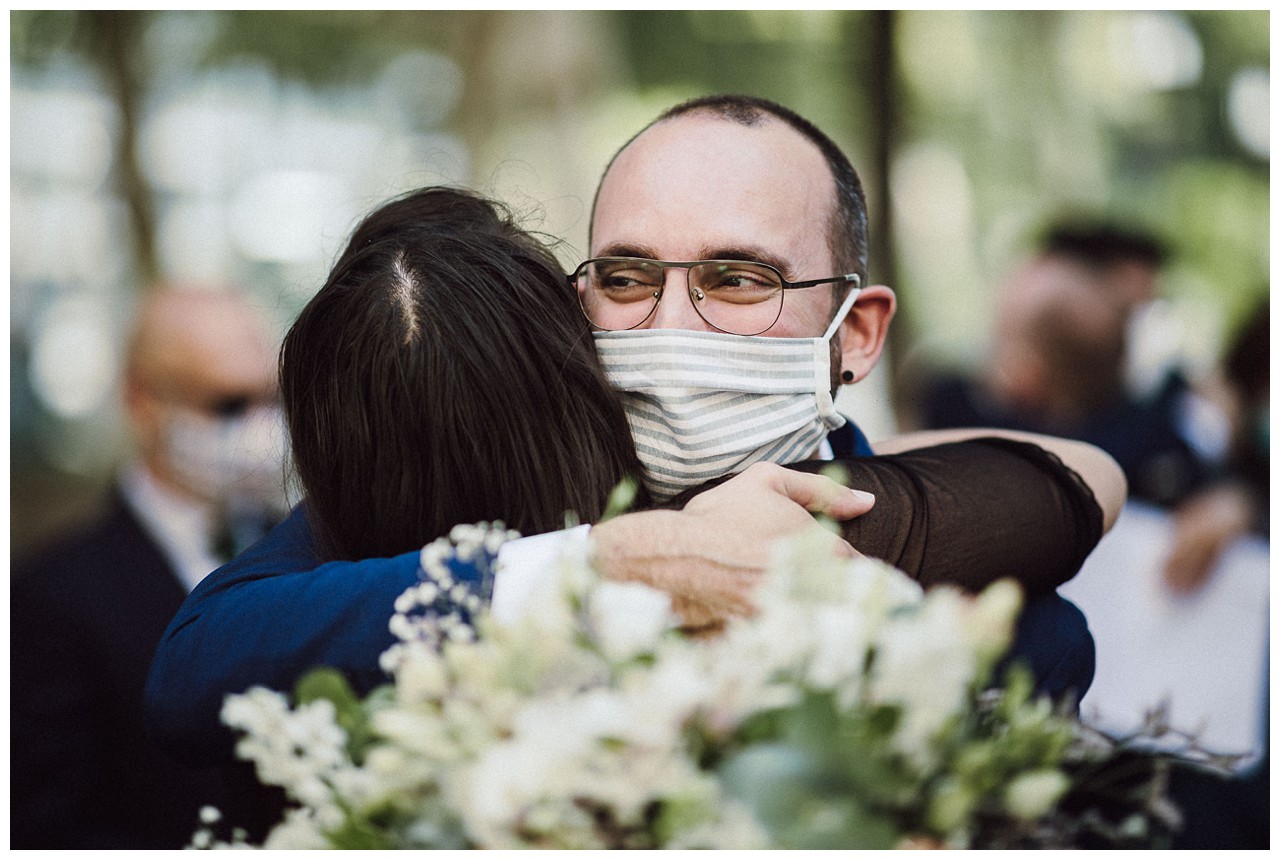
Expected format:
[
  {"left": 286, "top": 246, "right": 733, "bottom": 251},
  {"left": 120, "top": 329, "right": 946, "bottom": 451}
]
[{"left": 591, "top": 95, "right": 867, "bottom": 285}]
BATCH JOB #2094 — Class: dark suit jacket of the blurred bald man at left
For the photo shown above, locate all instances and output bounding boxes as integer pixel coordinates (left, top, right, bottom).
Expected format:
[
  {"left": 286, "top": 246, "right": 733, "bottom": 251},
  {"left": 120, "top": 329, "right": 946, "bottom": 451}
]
[{"left": 10, "top": 490, "right": 225, "bottom": 848}]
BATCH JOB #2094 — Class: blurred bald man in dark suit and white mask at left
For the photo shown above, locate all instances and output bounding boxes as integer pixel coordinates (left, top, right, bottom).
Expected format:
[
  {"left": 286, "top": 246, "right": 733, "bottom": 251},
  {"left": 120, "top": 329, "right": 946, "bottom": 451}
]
[{"left": 10, "top": 288, "right": 285, "bottom": 848}]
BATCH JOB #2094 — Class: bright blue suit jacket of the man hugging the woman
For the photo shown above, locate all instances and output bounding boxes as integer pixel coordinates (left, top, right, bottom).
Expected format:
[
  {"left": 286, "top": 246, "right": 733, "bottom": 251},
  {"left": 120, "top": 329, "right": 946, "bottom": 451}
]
[{"left": 146, "top": 424, "right": 1093, "bottom": 764}]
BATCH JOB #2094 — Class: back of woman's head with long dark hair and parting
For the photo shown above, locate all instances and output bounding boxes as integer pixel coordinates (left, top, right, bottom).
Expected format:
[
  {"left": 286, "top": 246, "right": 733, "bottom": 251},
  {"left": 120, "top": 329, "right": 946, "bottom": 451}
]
[{"left": 280, "top": 188, "right": 640, "bottom": 558}]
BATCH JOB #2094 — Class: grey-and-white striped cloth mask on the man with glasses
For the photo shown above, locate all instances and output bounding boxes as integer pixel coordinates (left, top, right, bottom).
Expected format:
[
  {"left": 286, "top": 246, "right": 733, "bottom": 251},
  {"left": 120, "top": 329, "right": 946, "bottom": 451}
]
[{"left": 595, "top": 289, "right": 859, "bottom": 502}]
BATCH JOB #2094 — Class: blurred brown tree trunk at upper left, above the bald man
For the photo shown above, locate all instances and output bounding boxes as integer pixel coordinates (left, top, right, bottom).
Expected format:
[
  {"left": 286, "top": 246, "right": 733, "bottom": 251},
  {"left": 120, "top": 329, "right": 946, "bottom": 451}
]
[{"left": 82, "top": 12, "right": 160, "bottom": 288}]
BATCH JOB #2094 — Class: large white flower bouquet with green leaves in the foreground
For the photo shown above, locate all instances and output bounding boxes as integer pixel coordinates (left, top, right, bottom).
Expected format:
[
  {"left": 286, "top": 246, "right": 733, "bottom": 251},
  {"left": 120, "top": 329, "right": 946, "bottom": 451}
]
[{"left": 207, "top": 517, "right": 1171, "bottom": 848}]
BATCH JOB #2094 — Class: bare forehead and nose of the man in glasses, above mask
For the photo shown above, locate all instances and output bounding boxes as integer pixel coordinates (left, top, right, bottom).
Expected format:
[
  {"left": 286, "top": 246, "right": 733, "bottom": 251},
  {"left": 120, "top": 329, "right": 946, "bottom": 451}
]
[{"left": 591, "top": 114, "right": 844, "bottom": 338}]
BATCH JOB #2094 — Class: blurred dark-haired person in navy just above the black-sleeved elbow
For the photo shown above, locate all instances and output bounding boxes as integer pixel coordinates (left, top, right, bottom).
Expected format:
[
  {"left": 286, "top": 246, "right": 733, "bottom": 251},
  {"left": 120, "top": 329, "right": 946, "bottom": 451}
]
[{"left": 919, "top": 225, "right": 1222, "bottom": 517}]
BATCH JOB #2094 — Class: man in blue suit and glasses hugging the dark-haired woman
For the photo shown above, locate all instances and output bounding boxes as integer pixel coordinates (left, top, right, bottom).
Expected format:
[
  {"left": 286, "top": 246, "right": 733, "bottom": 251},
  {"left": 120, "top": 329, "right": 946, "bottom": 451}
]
[{"left": 148, "top": 102, "right": 1123, "bottom": 756}]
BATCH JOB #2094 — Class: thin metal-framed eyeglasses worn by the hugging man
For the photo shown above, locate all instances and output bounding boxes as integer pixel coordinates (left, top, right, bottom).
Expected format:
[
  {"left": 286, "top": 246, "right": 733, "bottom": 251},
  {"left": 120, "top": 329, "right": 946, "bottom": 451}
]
[{"left": 568, "top": 257, "right": 860, "bottom": 337}]
